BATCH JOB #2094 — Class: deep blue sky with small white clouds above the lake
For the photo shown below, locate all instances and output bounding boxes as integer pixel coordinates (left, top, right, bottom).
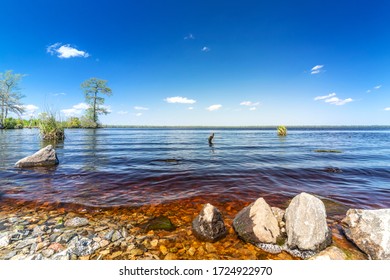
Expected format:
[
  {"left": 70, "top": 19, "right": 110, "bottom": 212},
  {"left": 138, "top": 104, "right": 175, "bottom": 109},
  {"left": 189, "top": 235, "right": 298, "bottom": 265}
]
[{"left": 0, "top": 0, "right": 390, "bottom": 126}]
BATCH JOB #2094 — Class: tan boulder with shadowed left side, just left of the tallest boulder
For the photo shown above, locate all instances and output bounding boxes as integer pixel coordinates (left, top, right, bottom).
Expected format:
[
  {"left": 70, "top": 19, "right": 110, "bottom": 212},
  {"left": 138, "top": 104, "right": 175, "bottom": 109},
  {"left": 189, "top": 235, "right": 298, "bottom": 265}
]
[{"left": 233, "top": 198, "right": 280, "bottom": 245}]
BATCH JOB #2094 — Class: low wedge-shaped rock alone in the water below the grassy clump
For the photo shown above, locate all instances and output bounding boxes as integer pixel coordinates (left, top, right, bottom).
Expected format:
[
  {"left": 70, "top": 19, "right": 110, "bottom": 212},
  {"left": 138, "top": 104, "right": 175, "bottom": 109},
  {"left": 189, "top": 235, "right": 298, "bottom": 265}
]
[{"left": 15, "top": 145, "right": 59, "bottom": 167}]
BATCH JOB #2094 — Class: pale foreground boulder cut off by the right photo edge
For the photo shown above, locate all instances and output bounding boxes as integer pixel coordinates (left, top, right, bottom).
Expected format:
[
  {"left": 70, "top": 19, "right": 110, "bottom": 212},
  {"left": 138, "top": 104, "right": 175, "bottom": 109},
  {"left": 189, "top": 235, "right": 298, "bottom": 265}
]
[{"left": 343, "top": 209, "right": 390, "bottom": 260}]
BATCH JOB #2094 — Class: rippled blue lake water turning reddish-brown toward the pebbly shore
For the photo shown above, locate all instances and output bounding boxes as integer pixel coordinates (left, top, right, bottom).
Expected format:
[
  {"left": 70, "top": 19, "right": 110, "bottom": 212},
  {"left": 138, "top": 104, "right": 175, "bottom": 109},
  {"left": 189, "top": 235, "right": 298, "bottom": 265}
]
[{"left": 0, "top": 128, "right": 390, "bottom": 213}]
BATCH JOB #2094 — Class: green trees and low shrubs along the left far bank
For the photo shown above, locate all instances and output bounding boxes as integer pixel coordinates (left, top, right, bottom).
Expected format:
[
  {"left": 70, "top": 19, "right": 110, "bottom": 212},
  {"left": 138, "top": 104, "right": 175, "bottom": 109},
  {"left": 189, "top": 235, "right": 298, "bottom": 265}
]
[{"left": 0, "top": 70, "right": 112, "bottom": 132}]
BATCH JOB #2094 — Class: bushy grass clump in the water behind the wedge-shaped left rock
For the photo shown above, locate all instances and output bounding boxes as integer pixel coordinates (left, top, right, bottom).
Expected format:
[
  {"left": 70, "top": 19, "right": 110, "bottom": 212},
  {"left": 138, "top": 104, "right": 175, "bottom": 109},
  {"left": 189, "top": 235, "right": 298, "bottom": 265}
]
[{"left": 38, "top": 113, "right": 65, "bottom": 141}]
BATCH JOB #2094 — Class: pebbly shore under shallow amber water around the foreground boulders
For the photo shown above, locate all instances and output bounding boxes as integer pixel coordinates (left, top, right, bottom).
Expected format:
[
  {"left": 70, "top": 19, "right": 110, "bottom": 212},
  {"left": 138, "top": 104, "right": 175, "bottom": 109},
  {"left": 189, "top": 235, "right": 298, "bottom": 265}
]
[{"left": 0, "top": 192, "right": 384, "bottom": 260}]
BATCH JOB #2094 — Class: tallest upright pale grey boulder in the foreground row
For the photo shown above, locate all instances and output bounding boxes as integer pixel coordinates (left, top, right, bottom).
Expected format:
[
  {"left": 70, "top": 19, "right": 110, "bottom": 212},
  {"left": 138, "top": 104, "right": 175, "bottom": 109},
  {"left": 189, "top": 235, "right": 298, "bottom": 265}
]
[{"left": 285, "top": 193, "right": 332, "bottom": 255}]
